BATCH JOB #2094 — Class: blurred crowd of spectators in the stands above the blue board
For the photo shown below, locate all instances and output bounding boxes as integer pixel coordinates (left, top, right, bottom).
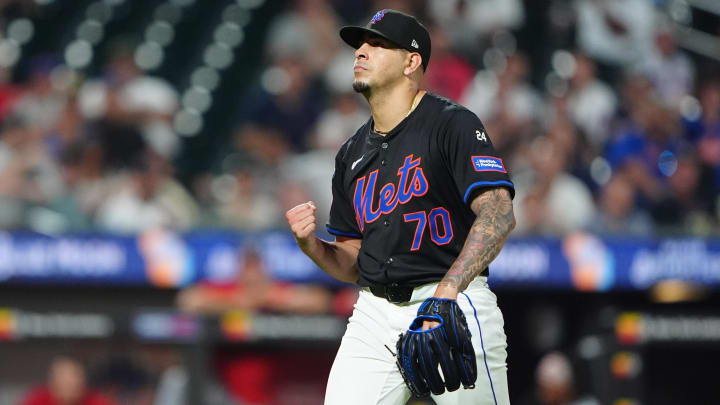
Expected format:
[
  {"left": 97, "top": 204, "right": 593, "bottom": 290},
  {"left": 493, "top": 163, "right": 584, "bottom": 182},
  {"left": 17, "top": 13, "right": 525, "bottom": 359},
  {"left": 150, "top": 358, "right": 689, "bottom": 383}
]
[{"left": 0, "top": 0, "right": 720, "bottom": 236}]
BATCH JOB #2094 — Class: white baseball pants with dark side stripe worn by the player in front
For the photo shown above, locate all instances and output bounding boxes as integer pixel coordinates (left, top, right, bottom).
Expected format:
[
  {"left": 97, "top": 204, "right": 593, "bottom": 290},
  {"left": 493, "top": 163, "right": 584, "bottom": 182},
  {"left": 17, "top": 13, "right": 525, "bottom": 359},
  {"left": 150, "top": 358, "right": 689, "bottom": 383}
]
[{"left": 325, "top": 277, "right": 510, "bottom": 405}]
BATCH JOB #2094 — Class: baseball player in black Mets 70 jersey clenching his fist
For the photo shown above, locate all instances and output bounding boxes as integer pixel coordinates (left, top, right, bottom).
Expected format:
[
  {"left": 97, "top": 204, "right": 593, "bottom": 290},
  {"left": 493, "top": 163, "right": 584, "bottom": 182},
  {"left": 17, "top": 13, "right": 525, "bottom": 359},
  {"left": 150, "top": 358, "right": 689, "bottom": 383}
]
[{"left": 286, "top": 10, "right": 515, "bottom": 405}]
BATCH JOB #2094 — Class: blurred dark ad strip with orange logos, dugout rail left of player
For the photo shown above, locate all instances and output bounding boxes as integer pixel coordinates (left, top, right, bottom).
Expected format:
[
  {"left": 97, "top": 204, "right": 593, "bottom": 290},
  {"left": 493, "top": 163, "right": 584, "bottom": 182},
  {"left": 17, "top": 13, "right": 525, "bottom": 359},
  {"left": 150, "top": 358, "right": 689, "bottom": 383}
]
[{"left": 0, "top": 307, "right": 347, "bottom": 344}]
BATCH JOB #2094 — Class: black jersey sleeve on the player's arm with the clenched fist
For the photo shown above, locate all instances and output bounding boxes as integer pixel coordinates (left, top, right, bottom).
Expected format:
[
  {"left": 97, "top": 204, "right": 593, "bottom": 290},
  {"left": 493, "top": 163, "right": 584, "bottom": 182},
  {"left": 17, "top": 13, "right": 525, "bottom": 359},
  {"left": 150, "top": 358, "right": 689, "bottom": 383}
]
[{"left": 325, "top": 147, "right": 362, "bottom": 238}]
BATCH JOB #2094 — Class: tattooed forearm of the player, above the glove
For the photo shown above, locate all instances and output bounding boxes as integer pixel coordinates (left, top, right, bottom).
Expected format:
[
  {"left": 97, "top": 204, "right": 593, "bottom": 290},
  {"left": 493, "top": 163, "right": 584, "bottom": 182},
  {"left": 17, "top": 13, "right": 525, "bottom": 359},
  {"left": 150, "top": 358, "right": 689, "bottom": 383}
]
[{"left": 440, "top": 188, "right": 515, "bottom": 291}]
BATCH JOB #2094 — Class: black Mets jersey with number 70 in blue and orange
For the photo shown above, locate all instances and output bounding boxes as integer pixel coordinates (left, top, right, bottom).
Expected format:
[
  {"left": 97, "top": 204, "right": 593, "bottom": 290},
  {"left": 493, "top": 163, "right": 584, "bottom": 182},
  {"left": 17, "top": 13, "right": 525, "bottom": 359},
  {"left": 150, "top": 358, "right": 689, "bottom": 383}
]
[{"left": 327, "top": 93, "right": 515, "bottom": 286}]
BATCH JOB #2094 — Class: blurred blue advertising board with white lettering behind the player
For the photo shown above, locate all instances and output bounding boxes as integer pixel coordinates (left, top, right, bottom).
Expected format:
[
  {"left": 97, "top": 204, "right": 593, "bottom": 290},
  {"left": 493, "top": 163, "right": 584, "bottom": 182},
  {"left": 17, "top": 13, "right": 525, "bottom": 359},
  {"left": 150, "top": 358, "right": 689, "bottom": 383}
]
[{"left": 0, "top": 229, "right": 720, "bottom": 291}]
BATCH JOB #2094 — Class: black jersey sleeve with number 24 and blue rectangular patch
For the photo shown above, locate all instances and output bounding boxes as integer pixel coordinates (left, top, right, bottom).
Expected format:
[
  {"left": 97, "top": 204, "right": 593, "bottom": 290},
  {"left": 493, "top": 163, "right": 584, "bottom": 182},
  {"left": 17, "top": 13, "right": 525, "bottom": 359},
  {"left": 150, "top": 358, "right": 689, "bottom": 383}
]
[{"left": 440, "top": 110, "right": 515, "bottom": 204}]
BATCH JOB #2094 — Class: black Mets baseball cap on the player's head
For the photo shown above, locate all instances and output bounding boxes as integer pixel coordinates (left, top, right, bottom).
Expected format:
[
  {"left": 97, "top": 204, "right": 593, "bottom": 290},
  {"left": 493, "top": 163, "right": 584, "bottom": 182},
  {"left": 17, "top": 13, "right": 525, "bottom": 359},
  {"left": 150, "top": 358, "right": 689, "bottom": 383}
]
[{"left": 340, "top": 9, "right": 430, "bottom": 70}]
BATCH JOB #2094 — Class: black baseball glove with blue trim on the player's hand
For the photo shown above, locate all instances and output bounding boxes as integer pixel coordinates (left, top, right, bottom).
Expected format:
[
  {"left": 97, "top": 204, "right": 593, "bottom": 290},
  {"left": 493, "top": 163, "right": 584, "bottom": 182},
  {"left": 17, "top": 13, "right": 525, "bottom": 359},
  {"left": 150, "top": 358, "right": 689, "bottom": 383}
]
[{"left": 396, "top": 298, "right": 477, "bottom": 397}]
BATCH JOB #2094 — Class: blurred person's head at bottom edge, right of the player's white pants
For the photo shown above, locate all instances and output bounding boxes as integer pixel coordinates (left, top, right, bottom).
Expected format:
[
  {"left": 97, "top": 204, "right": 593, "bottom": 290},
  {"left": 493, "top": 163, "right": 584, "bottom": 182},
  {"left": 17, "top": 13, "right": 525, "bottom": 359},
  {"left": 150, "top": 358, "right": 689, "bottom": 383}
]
[{"left": 523, "top": 352, "right": 600, "bottom": 405}]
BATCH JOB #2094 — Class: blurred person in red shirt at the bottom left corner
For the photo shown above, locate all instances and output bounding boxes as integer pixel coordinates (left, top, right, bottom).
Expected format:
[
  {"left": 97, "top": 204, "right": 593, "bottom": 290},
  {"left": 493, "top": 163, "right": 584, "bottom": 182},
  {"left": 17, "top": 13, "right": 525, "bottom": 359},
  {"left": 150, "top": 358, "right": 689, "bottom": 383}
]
[{"left": 18, "top": 357, "right": 114, "bottom": 405}]
